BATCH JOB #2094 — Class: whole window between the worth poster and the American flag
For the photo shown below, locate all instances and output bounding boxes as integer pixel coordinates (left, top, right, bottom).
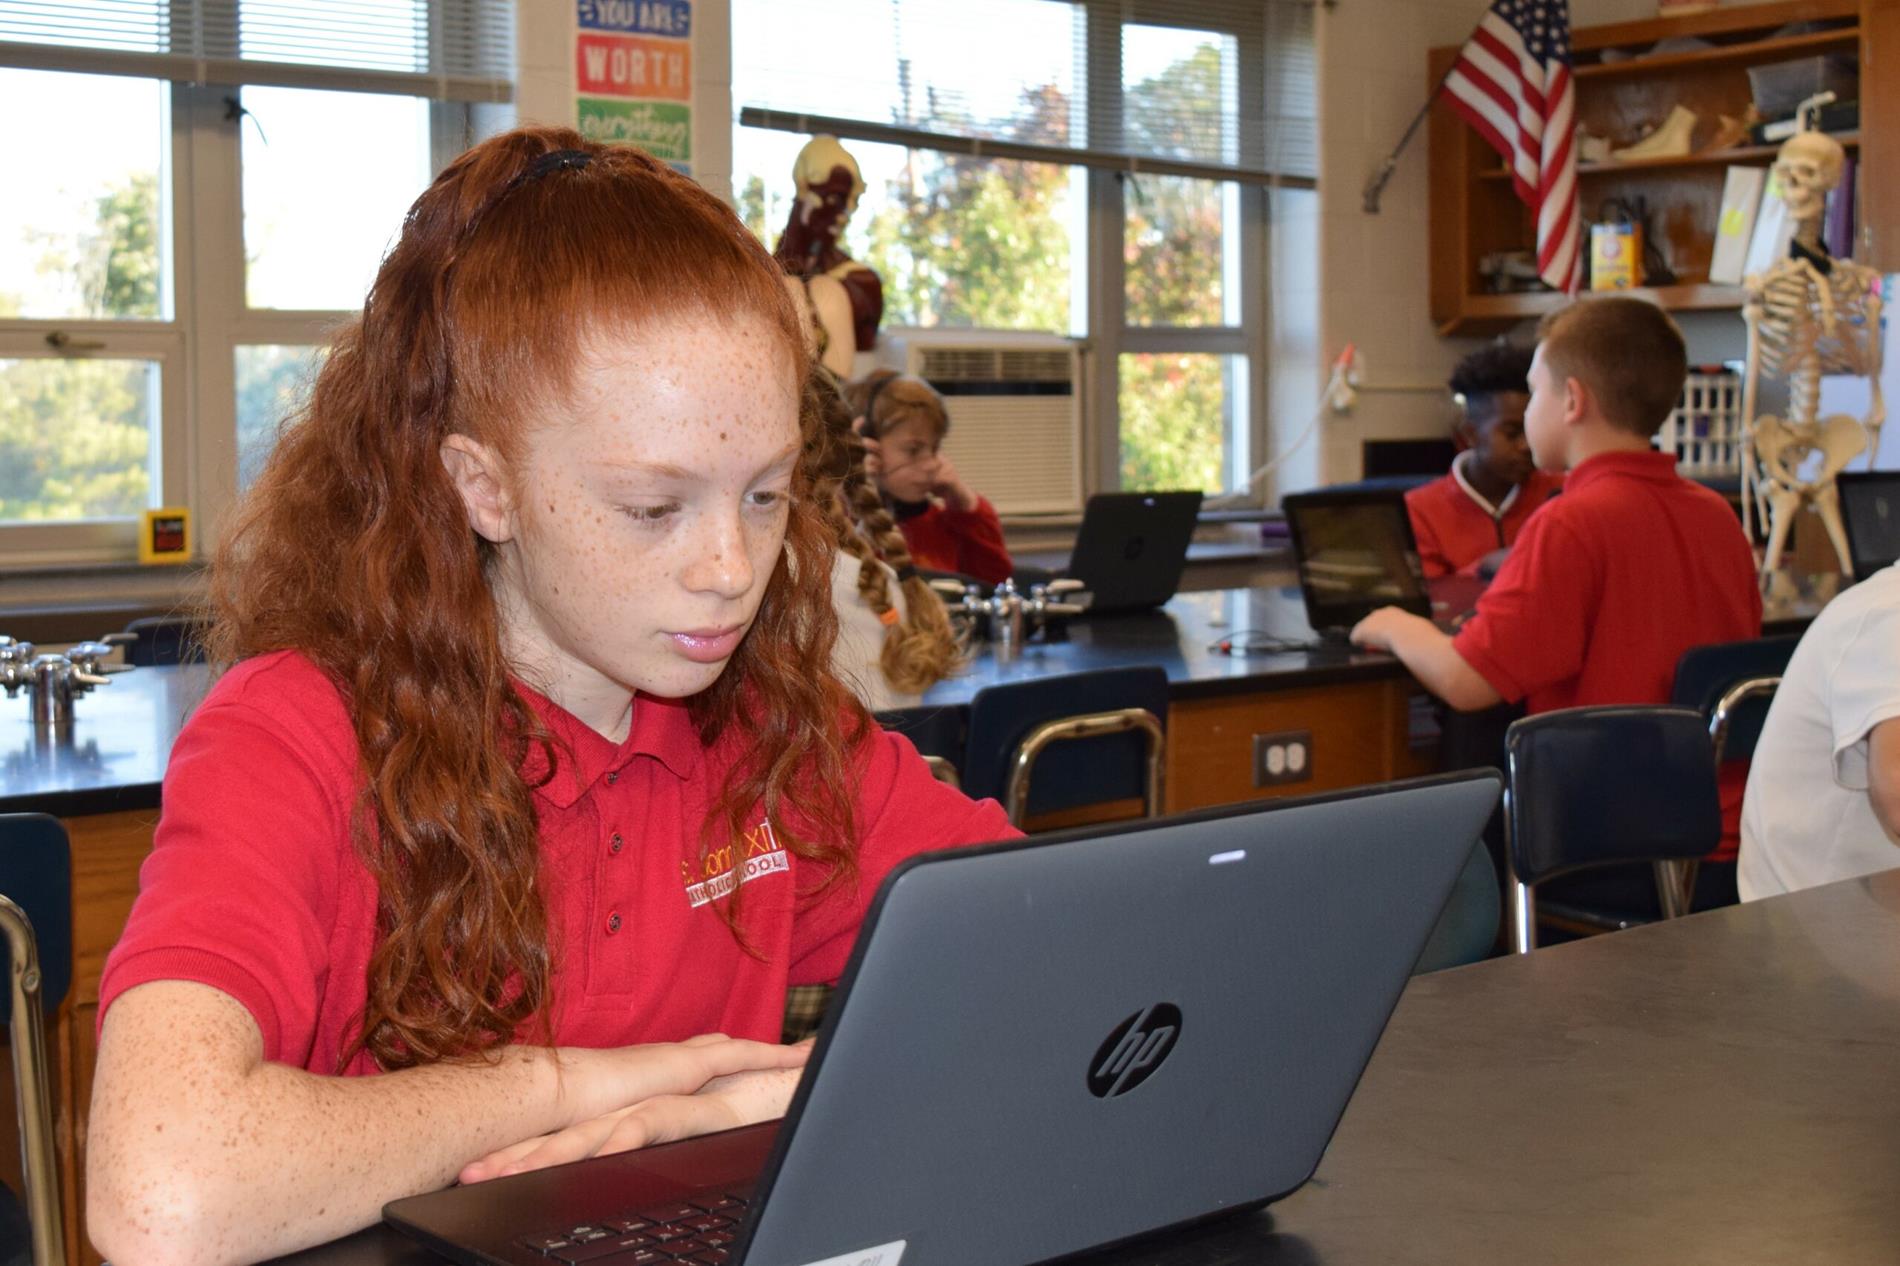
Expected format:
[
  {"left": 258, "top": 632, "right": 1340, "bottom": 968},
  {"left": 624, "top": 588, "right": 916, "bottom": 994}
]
[{"left": 733, "top": 0, "right": 1317, "bottom": 504}]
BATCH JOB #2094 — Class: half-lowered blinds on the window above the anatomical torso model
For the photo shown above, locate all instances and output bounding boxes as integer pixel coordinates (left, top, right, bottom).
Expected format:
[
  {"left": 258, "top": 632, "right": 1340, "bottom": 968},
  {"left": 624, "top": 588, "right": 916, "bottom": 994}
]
[{"left": 732, "top": 0, "right": 1319, "bottom": 184}]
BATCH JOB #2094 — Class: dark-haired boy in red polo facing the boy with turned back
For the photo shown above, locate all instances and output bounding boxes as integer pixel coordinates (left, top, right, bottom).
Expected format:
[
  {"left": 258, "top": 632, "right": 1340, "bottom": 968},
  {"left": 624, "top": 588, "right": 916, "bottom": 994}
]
[{"left": 1406, "top": 342, "right": 1564, "bottom": 576}]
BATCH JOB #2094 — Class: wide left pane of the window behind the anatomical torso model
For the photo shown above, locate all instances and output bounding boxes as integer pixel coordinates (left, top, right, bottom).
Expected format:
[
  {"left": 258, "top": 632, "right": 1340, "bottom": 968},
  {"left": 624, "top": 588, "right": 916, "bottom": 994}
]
[{"left": 732, "top": 0, "right": 1087, "bottom": 335}]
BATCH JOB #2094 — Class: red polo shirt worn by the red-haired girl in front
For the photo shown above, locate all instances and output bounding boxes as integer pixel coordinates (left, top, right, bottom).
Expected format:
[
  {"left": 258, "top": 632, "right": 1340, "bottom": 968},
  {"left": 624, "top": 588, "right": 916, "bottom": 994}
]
[{"left": 99, "top": 654, "right": 1017, "bottom": 1074}]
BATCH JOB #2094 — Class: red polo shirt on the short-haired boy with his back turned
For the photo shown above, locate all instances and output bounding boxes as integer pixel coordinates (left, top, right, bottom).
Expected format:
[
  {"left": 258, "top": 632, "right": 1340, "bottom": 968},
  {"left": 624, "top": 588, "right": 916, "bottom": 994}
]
[{"left": 1454, "top": 452, "right": 1761, "bottom": 861}]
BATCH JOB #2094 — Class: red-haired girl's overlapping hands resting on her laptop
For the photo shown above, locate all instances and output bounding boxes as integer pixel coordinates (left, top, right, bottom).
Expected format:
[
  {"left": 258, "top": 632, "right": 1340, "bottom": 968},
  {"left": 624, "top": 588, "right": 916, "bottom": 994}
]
[{"left": 458, "top": 1034, "right": 811, "bottom": 1182}]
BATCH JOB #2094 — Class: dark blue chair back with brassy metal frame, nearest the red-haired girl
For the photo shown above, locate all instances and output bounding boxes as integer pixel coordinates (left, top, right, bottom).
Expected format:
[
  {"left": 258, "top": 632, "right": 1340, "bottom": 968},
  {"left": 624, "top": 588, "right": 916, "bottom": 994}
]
[{"left": 963, "top": 665, "right": 1169, "bottom": 827}]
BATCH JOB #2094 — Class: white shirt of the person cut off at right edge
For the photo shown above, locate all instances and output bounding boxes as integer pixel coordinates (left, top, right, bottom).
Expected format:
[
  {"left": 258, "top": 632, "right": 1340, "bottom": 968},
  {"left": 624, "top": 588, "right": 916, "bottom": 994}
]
[{"left": 1737, "top": 565, "right": 1900, "bottom": 901}]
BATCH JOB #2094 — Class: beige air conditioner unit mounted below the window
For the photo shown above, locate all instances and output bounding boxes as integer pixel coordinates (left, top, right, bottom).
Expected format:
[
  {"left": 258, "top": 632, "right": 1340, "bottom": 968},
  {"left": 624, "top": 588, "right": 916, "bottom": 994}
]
[{"left": 876, "top": 327, "right": 1083, "bottom": 515}]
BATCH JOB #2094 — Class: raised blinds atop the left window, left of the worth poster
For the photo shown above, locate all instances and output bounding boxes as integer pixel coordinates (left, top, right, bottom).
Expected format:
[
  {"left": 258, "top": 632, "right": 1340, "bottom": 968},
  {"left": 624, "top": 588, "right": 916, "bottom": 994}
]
[{"left": 0, "top": 0, "right": 515, "bottom": 101}]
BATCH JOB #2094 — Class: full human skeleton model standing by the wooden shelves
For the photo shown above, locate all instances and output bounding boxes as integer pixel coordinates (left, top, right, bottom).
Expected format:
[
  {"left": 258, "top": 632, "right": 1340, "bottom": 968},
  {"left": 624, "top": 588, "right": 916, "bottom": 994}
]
[{"left": 1742, "top": 99, "right": 1887, "bottom": 574}]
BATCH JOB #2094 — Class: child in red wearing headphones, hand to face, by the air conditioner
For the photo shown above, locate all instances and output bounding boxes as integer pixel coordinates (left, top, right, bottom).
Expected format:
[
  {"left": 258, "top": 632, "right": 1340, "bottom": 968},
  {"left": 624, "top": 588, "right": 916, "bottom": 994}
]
[{"left": 846, "top": 369, "right": 1015, "bottom": 585}]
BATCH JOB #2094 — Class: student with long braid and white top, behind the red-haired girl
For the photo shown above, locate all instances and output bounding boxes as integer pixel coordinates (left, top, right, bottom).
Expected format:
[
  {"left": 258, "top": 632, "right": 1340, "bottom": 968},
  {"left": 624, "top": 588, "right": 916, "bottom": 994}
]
[{"left": 809, "top": 367, "right": 960, "bottom": 711}]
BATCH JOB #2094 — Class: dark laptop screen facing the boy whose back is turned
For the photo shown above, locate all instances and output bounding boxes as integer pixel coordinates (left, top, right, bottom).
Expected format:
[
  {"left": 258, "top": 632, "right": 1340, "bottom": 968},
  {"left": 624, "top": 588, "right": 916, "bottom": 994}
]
[{"left": 1281, "top": 489, "right": 1431, "bottom": 637}]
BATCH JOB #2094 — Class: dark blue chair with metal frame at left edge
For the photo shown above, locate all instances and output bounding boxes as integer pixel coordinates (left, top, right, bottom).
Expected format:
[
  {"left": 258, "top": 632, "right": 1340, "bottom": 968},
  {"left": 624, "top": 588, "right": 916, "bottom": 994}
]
[{"left": 0, "top": 814, "right": 72, "bottom": 1266}]
